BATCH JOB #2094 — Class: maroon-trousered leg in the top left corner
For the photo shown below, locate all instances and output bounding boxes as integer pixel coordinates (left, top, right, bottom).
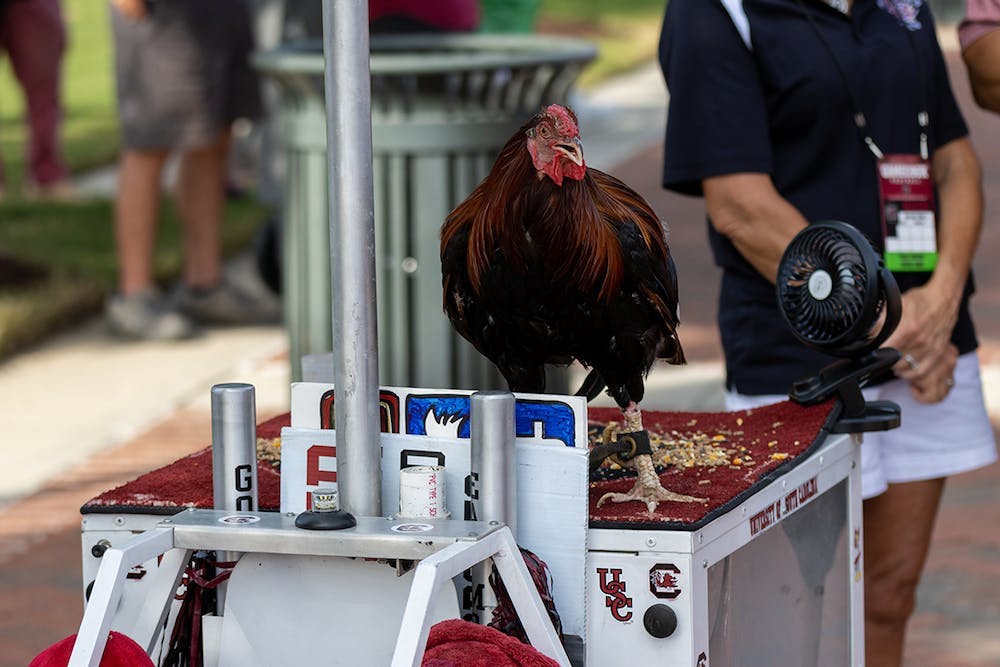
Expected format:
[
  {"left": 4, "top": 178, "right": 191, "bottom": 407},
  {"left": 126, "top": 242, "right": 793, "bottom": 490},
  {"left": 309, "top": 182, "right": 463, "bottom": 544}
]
[{"left": 4, "top": 0, "right": 69, "bottom": 190}]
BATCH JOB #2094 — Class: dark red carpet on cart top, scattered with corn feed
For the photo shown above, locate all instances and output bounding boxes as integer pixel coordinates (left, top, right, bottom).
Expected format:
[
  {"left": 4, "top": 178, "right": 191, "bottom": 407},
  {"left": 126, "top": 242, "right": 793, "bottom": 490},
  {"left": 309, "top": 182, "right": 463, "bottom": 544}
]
[{"left": 80, "top": 401, "right": 837, "bottom": 530}]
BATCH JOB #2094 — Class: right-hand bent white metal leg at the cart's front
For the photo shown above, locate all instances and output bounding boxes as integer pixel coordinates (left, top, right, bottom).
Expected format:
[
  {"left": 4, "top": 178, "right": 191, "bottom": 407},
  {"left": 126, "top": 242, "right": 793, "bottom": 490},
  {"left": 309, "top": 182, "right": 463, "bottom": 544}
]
[{"left": 392, "top": 526, "right": 570, "bottom": 667}]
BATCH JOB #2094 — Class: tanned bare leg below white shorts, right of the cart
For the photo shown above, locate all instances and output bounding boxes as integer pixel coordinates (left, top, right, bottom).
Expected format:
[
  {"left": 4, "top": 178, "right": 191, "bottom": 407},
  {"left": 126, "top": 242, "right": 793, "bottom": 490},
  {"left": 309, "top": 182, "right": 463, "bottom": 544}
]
[{"left": 862, "top": 478, "right": 944, "bottom": 667}]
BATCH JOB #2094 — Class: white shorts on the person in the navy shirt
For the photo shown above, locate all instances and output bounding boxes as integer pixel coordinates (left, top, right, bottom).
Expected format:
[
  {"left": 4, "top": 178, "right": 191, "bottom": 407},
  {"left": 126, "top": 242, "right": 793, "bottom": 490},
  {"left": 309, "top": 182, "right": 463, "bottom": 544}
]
[{"left": 726, "top": 352, "right": 997, "bottom": 498}]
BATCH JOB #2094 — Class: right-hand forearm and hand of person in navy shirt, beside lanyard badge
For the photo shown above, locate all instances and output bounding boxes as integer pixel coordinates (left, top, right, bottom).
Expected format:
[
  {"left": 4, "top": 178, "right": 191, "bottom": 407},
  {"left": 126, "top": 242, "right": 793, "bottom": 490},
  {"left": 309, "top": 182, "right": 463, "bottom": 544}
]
[{"left": 885, "top": 137, "right": 983, "bottom": 403}]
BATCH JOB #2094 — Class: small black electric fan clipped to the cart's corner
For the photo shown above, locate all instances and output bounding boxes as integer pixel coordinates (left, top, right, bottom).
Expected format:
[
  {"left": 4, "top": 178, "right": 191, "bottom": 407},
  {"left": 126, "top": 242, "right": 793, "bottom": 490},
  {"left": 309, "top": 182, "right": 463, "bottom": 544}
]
[{"left": 777, "top": 221, "right": 901, "bottom": 433}]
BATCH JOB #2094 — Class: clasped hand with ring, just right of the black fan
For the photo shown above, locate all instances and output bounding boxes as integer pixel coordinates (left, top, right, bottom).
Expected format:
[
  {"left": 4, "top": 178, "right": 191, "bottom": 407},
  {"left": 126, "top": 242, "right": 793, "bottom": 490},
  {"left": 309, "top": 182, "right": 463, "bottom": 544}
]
[{"left": 885, "top": 285, "right": 959, "bottom": 403}]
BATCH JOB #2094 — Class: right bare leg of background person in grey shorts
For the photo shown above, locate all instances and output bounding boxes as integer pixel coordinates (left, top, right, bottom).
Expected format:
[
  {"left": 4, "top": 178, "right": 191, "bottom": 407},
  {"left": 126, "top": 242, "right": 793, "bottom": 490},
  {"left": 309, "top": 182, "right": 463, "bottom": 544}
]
[{"left": 177, "top": 133, "right": 229, "bottom": 288}]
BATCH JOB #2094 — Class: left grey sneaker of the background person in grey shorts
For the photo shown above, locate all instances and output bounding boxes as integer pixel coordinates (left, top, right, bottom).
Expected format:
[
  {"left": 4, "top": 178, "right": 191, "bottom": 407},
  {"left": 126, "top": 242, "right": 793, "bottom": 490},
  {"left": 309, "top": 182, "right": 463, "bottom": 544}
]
[{"left": 104, "top": 288, "right": 195, "bottom": 340}]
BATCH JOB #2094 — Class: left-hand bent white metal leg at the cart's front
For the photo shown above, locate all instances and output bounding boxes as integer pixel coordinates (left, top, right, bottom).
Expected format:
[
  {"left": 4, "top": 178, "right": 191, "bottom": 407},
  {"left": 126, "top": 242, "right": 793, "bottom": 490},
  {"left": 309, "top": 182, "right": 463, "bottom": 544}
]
[{"left": 69, "top": 528, "right": 176, "bottom": 667}]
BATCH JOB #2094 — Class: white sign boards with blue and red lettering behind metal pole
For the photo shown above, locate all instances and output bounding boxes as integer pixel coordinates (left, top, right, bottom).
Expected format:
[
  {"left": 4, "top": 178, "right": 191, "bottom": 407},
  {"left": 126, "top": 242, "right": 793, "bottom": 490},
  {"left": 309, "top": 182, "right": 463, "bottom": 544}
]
[{"left": 281, "top": 383, "right": 589, "bottom": 636}]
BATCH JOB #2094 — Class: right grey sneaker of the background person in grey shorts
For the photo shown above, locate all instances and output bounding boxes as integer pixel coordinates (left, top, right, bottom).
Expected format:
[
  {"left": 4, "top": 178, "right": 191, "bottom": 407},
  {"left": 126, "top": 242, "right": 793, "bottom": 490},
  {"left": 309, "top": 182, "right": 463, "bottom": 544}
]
[{"left": 173, "top": 282, "right": 281, "bottom": 324}]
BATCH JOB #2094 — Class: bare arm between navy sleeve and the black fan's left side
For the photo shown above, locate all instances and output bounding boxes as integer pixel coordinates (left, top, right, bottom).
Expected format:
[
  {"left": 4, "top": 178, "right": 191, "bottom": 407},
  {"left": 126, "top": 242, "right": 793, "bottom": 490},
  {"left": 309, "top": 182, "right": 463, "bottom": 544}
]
[{"left": 702, "top": 173, "right": 808, "bottom": 282}]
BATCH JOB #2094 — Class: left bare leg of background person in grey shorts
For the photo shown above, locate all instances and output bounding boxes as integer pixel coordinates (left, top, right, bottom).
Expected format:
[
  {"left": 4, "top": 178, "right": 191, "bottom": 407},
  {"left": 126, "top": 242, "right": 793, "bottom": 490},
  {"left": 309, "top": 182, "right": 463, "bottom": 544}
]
[{"left": 115, "top": 150, "right": 167, "bottom": 295}]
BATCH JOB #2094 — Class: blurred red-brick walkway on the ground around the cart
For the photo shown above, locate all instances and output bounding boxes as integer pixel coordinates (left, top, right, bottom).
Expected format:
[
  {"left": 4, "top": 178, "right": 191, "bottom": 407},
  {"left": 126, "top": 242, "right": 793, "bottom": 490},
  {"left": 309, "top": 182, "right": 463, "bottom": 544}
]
[{"left": 0, "top": 48, "right": 1000, "bottom": 667}]
